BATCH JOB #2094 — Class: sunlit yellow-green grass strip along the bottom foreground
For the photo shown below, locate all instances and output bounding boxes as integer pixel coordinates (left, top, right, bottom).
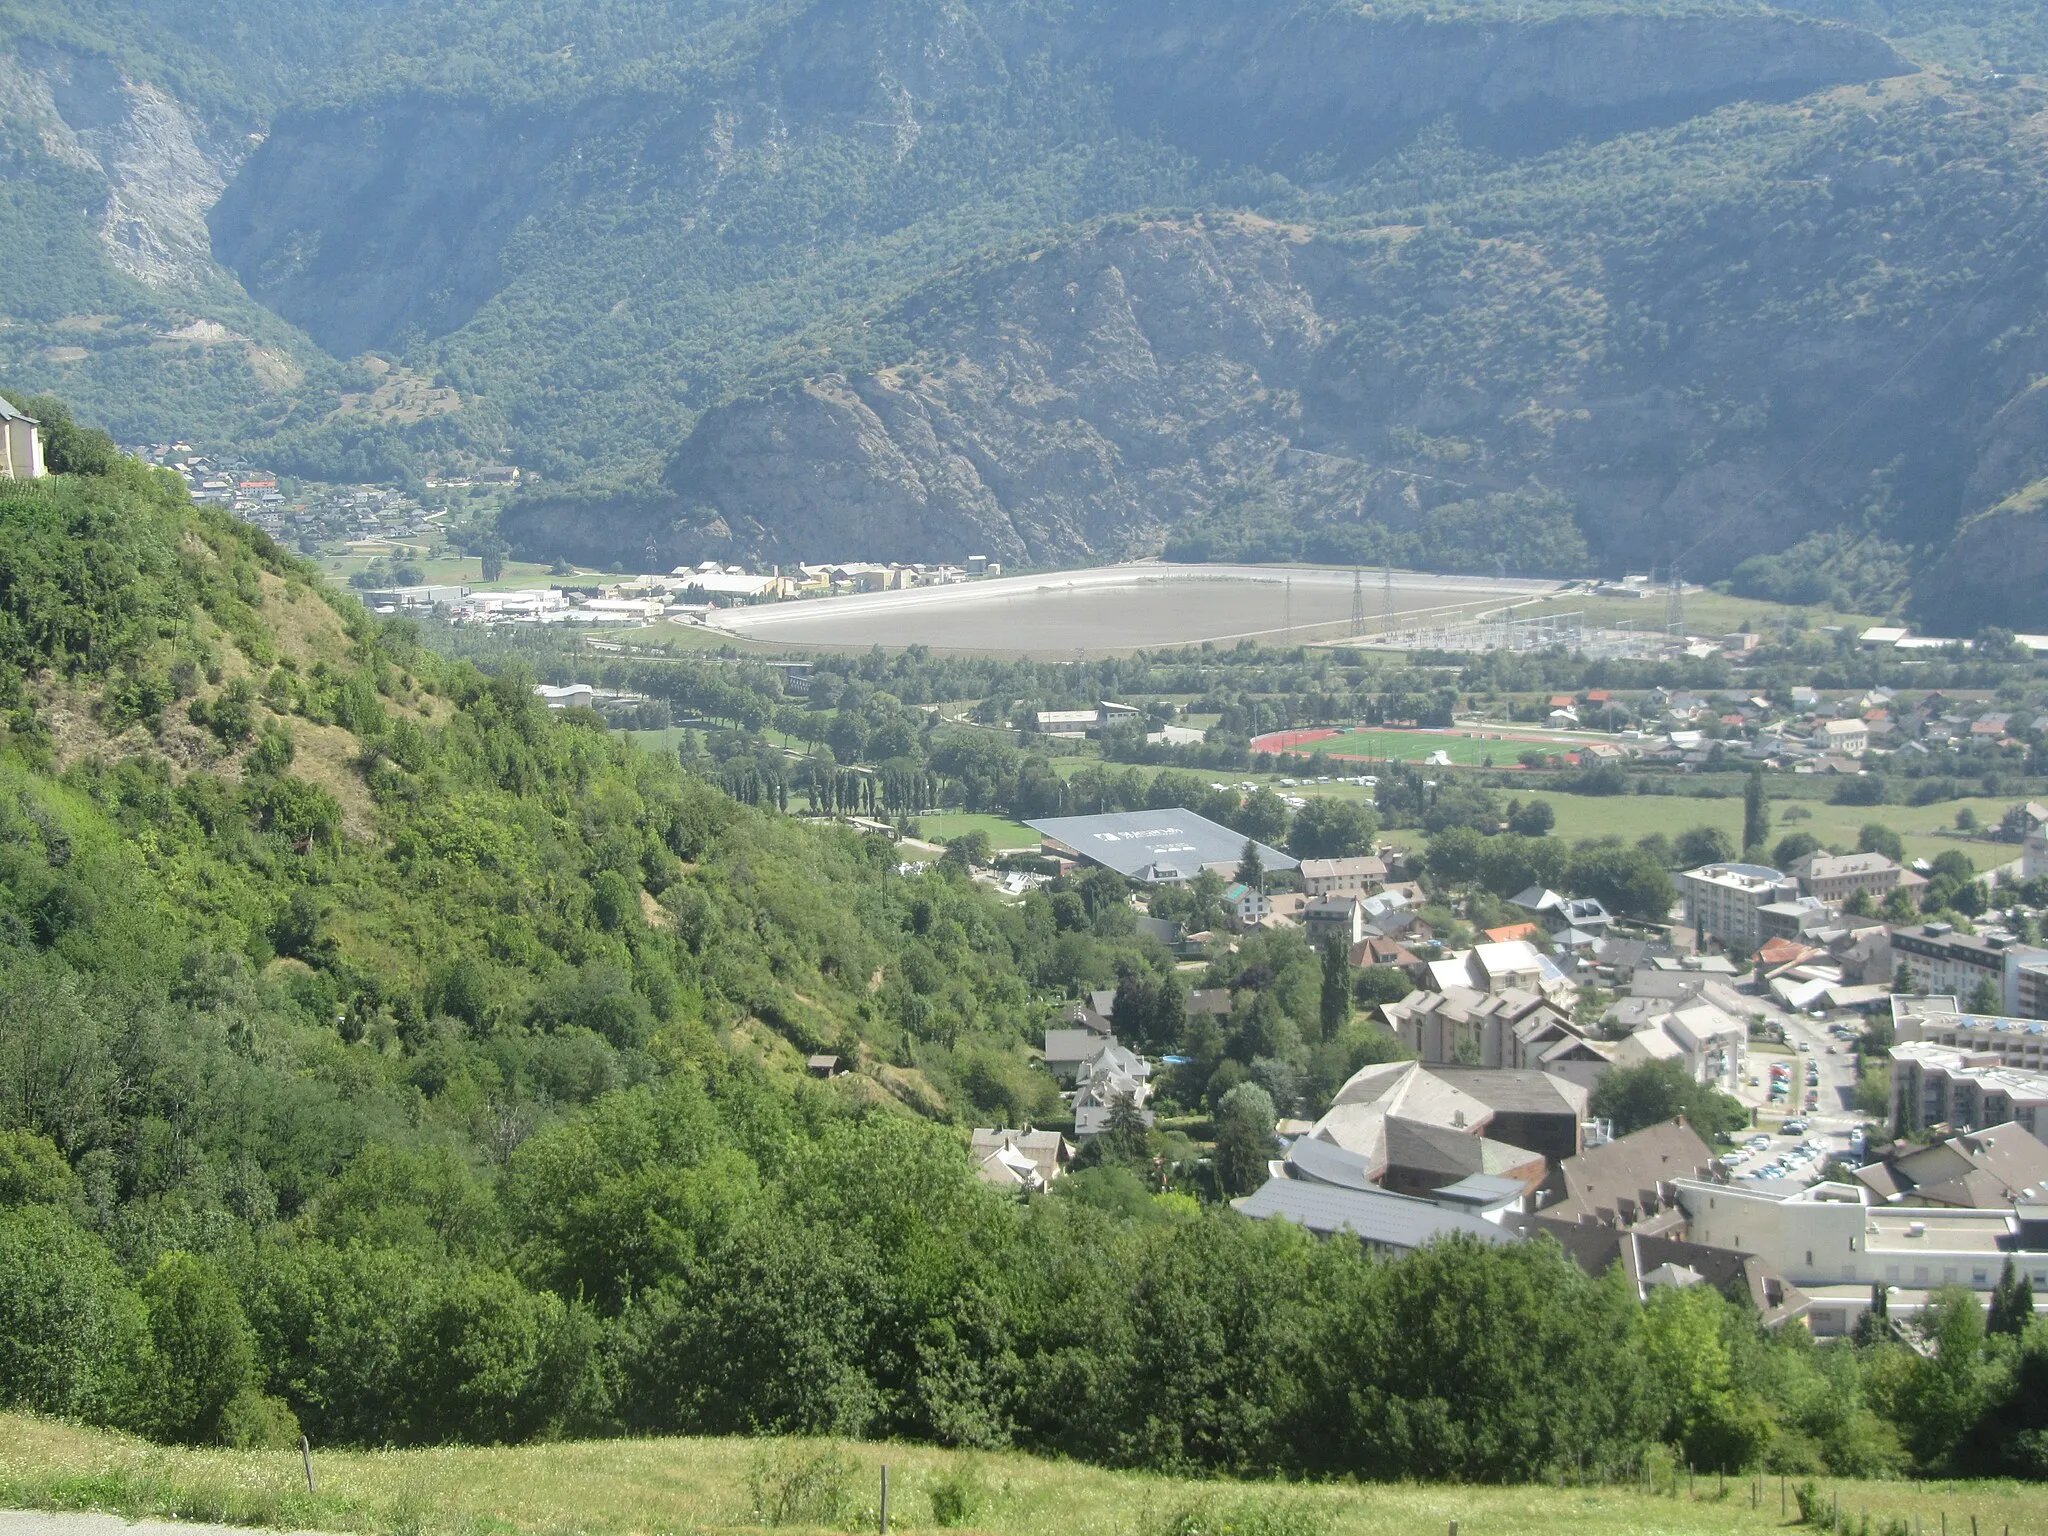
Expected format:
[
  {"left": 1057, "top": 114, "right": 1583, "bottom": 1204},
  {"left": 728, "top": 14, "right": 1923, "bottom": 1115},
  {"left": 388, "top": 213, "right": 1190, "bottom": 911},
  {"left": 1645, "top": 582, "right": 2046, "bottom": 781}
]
[{"left": 0, "top": 1415, "right": 2048, "bottom": 1536}]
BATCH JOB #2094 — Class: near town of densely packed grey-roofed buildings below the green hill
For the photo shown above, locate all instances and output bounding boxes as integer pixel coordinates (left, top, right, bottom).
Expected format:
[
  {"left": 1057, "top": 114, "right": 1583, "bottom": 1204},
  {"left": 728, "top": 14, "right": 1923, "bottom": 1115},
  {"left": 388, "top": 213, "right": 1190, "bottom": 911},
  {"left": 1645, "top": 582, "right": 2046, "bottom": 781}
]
[{"left": 973, "top": 782, "right": 2048, "bottom": 1335}]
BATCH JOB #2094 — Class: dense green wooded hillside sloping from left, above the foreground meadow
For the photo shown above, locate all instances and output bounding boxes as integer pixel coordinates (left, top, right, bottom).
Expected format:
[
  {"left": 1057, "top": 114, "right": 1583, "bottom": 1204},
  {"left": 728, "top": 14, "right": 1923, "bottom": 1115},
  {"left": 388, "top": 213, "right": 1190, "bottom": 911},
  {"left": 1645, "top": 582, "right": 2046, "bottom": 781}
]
[{"left": 0, "top": 430, "right": 2048, "bottom": 1479}]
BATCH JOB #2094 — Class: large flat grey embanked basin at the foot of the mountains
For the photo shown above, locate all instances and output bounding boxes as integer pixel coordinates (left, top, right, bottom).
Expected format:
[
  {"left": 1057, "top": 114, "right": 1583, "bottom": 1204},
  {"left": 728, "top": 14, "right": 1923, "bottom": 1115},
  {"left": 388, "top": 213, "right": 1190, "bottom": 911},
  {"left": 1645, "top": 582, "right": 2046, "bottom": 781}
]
[{"left": 700, "top": 563, "right": 1556, "bottom": 657}]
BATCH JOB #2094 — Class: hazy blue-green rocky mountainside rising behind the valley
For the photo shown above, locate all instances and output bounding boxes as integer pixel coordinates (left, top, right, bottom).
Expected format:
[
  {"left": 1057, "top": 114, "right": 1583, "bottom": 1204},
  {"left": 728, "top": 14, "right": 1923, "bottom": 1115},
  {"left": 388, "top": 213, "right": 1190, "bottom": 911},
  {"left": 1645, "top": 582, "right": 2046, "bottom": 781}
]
[{"left": 0, "top": 0, "right": 2048, "bottom": 629}]
